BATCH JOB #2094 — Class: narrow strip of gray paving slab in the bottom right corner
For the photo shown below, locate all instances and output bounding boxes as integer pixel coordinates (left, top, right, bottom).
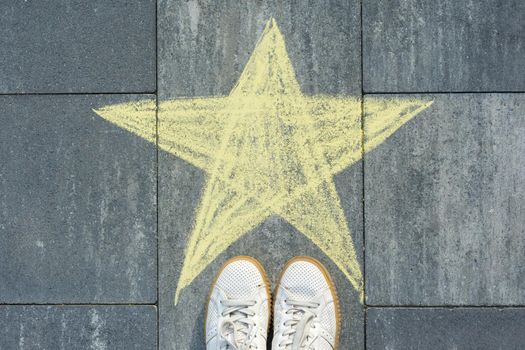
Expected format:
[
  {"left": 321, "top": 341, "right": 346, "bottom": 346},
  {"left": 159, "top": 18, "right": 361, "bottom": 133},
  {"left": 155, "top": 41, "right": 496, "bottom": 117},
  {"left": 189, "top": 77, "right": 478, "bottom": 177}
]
[{"left": 366, "top": 308, "right": 525, "bottom": 350}]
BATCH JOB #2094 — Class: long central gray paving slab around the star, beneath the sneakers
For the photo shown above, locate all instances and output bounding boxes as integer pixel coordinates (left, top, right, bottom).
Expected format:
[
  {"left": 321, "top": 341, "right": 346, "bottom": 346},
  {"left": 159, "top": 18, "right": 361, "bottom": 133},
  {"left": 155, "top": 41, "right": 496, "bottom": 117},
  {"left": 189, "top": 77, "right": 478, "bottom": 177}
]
[{"left": 155, "top": 0, "right": 364, "bottom": 350}]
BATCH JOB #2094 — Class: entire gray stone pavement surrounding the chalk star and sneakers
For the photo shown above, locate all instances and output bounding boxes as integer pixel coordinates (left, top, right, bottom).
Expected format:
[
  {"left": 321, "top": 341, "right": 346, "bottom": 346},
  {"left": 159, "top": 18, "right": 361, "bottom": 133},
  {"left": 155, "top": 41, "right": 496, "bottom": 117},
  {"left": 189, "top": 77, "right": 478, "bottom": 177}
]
[{"left": 0, "top": 0, "right": 525, "bottom": 350}]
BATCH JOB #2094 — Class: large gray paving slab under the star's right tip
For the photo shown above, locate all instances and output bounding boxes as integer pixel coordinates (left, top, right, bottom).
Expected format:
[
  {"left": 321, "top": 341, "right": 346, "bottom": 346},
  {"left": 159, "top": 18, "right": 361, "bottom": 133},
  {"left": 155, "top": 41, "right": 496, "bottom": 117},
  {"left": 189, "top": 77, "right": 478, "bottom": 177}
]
[{"left": 365, "top": 94, "right": 525, "bottom": 305}]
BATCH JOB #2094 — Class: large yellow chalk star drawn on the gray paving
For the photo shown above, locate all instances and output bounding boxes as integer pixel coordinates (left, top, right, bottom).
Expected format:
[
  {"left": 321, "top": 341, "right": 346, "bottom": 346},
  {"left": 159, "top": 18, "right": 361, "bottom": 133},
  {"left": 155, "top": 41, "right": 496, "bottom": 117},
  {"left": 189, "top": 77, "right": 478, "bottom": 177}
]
[{"left": 95, "top": 19, "right": 431, "bottom": 300}]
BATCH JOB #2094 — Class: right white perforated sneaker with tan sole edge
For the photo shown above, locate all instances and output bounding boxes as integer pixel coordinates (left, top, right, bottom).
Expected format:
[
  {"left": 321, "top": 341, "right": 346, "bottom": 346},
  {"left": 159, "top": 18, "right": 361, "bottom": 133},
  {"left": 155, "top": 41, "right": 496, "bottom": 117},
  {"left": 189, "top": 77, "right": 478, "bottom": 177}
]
[{"left": 272, "top": 256, "right": 340, "bottom": 350}]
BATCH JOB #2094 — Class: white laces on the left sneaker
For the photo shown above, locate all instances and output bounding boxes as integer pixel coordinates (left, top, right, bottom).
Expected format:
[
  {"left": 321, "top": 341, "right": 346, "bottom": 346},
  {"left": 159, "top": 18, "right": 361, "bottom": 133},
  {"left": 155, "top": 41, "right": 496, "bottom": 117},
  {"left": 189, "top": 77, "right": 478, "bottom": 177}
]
[{"left": 219, "top": 300, "right": 256, "bottom": 350}]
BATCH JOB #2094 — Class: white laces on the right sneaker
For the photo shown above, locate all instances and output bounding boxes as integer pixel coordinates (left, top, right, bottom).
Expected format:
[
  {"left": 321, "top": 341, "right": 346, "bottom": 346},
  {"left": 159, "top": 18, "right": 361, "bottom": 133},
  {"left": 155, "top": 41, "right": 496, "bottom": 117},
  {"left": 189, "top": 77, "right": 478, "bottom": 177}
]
[{"left": 279, "top": 299, "right": 320, "bottom": 350}]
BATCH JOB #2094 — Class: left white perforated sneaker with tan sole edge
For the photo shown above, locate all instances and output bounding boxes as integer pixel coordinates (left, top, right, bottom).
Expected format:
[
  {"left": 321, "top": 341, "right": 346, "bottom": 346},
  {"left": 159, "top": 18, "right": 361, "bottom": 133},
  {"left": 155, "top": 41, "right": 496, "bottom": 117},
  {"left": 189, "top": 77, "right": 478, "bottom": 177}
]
[{"left": 205, "top": 256, "right": 271, "bottom": 350}]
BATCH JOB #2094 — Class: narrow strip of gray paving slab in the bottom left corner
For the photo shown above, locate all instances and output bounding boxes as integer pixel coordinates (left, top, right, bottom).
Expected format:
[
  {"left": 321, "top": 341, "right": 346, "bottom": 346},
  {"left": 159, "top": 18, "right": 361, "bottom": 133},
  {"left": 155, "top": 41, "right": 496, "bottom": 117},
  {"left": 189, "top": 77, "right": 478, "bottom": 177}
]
[{"left": 0, "top": 306, "right": 157, "bottom": 350}]
